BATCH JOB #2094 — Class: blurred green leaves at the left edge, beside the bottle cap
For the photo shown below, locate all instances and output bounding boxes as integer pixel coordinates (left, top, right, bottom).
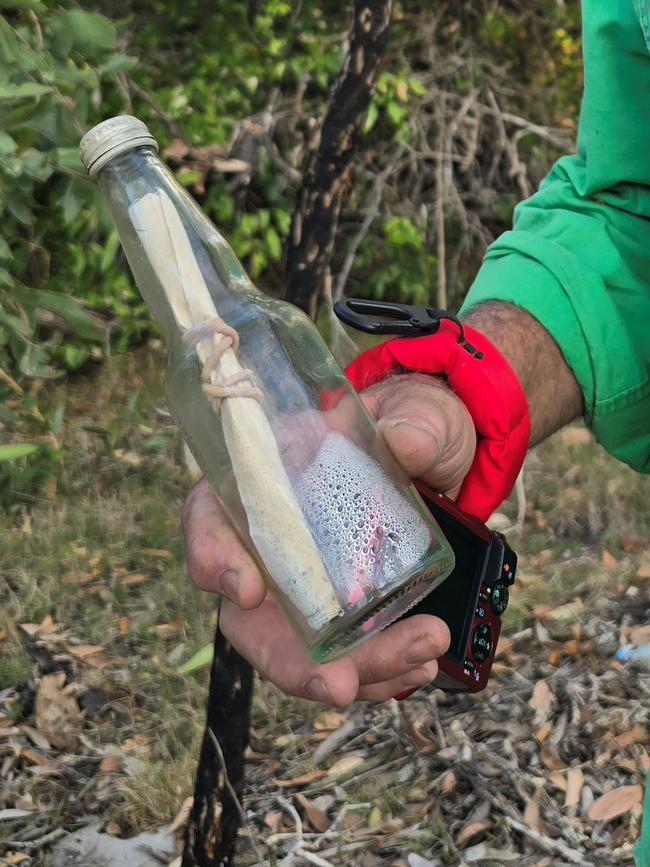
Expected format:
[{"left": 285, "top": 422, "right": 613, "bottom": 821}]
[{"left": 0, "top": 0, "right": 130, "bottom": 400}]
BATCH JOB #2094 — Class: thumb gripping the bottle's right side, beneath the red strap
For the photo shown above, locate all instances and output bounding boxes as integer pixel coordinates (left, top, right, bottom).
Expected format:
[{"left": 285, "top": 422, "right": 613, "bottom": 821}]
[{"left": 361, "top": 373, "right": 476, "bottom": 498}]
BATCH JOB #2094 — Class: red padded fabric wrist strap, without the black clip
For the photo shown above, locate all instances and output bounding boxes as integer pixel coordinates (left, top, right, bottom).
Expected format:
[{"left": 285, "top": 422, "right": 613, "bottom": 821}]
[{"left": 346, "top": 320, "right": 530, "bottom": 521}]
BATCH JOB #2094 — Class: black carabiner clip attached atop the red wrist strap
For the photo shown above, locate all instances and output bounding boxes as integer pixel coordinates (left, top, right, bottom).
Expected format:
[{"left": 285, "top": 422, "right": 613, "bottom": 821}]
[{"left": 334, "top": 298, "right": 483, "bottom": 359}]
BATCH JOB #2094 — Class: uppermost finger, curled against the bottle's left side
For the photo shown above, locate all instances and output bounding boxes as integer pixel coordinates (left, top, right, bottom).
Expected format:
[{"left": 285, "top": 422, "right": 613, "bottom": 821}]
[{"left": 182, "top": 479, "right": 266, "bottom": 608}]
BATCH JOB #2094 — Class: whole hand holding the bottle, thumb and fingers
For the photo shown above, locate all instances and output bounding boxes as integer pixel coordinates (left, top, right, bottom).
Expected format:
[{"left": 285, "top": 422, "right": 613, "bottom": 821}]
[{"left": 183, "top": 374, "right": 476, "bottom": 707}]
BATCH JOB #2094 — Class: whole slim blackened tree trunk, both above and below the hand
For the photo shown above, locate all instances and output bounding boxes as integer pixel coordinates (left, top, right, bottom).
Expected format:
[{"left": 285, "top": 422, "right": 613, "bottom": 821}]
[{"left": 182, "top": 0, "right": 392, "bottom": 867}]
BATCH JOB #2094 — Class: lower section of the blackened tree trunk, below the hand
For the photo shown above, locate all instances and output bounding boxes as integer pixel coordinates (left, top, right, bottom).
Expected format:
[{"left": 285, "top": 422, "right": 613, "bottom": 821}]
[{"left": 182, "top": 627, "right": 253, "bottom": 867}]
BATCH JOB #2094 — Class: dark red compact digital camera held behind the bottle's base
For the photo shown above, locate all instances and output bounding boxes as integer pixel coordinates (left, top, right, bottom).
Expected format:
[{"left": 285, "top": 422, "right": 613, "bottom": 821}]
[{"left": 398, "top": 482, "right": 517, "bottom": 698}]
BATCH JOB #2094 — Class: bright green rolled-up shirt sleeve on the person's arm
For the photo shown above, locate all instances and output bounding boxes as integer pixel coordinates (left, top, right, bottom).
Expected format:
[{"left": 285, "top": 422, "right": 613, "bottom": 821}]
[{"left": 462, "top": 0, "right": 650, "bottom": 472}]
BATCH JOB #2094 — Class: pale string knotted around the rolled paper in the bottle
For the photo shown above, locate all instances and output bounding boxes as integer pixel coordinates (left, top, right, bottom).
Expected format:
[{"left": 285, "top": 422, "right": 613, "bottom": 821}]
[{"left": 183, "top": 316, "right": 262, "bottom": 412}]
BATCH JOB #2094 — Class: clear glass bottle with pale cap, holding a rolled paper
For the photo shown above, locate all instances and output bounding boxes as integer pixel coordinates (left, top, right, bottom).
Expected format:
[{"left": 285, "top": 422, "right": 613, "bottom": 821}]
[{"left": 81, "top": 116, "right": 454, "bottom": 661}]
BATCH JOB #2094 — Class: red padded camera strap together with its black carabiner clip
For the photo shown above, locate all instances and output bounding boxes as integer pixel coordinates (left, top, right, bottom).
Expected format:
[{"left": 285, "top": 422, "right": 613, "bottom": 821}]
[{"left": 335, "top": 299, "right": 530, "bottom": 521}]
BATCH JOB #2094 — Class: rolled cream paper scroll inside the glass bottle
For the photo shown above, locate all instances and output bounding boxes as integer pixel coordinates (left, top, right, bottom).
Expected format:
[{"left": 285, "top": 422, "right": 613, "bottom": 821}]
[{"left": 129, "top": 190, "right": 342, "bottom": 631}]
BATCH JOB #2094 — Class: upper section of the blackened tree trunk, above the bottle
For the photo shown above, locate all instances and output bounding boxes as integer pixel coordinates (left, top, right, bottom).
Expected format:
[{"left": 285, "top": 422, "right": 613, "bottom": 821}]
[{"left": 285, "top": 0, "right": 392, "bottom": 319}]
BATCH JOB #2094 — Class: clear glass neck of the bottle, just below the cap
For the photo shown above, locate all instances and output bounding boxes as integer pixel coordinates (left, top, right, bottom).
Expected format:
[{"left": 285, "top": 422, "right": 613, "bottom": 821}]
[{"left": 98, "top": 147, "right": 255, "bottom": 346}]
